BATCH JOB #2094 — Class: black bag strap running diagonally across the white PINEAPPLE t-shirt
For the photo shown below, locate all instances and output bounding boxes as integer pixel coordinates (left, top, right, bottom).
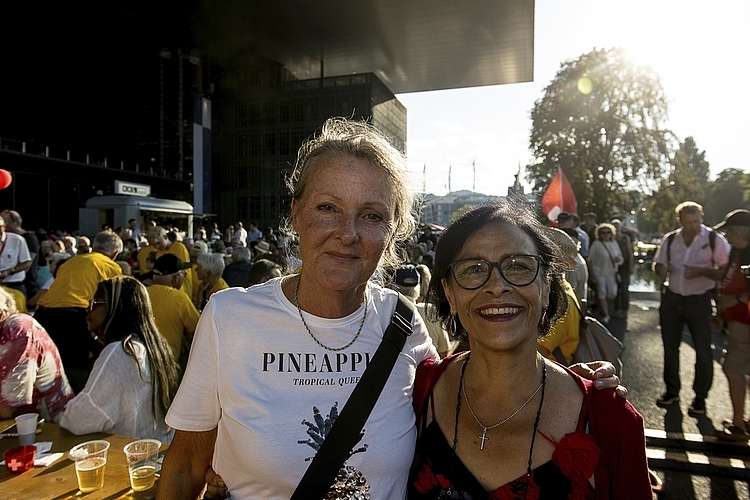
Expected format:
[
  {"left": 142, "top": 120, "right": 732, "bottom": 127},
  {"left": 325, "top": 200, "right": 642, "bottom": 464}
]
[{"left": 290, "top": 294, "right": 414, "bottom": 500}]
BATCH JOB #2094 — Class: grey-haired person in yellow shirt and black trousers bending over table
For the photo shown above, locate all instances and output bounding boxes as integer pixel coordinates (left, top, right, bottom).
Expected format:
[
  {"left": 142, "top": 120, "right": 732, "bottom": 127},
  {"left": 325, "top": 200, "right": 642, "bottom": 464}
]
[{"left": 34, "top": 231, "right": 122, "bottom": 393}]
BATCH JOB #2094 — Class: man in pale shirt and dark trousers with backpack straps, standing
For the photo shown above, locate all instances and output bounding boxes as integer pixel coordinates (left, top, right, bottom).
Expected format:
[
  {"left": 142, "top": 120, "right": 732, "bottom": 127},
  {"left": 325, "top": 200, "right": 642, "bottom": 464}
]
[{"left": 654, "top": 201, "right": 729, "bottom": 417}]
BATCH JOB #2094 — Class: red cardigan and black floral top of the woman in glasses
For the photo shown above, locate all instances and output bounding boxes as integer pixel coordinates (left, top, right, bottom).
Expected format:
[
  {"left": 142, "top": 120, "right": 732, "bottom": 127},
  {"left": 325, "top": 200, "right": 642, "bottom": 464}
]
[{"left": 409, "top": 355, "right": 652, "bottom": 500}]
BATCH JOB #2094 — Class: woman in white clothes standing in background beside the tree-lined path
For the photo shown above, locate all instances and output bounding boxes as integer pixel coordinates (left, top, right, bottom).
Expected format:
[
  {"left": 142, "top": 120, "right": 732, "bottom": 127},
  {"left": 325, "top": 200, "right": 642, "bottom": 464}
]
[{"left": 589, "top": 222, "right": 624, "bottom": 323}]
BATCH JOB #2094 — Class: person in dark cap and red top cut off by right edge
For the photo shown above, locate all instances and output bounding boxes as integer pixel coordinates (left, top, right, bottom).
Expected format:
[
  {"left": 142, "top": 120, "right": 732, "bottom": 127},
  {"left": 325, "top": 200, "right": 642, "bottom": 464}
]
[{"left": 715, "top": 210, "right": 750, "bottom": 441}]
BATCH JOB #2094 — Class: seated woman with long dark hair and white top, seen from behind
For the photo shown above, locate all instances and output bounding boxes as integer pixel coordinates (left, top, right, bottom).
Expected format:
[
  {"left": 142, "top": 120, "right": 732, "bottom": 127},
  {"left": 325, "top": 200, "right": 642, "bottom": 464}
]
[{"left": 60, "top": 276, "right": 179, "bottom": 443}]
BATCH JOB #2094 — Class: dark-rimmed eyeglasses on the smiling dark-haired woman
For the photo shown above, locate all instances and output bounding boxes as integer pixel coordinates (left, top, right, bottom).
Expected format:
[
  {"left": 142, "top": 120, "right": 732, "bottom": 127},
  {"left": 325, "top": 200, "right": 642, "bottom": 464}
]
[{"left": 450, "top": 255, "right": 542, "bottom": 290}]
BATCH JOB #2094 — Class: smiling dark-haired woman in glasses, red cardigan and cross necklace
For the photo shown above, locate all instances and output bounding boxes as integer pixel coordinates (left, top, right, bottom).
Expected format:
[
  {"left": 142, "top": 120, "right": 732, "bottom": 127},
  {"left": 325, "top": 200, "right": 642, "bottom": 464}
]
[{"left": 409, "top": 202, "right": 651, "bottom": 500}]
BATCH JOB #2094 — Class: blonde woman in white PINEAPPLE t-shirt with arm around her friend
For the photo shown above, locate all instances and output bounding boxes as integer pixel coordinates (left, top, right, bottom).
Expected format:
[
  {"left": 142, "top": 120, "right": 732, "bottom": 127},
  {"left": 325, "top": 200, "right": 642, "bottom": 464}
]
[{"left": 195, "top": 118, "right": 628, "bottom": 500}]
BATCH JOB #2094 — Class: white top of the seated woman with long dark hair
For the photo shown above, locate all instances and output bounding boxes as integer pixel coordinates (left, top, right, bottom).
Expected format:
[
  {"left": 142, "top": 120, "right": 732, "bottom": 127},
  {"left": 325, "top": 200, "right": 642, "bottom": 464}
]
[{"left": 60, "top": 342, "right": 174, "bottom": 443}]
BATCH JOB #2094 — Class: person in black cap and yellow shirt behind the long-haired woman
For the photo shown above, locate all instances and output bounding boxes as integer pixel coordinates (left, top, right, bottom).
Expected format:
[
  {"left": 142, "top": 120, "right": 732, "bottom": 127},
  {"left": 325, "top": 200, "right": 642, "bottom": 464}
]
[{"left": 146, "top": 254, "right": 200, "bottom": 368}]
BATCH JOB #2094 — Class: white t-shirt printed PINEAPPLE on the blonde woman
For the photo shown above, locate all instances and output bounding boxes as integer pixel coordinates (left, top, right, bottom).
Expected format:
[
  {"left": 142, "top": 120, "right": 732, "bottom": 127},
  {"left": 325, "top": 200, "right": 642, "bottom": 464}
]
[{"left": 167, "top": 279, "right": 437, "bottom": 500}]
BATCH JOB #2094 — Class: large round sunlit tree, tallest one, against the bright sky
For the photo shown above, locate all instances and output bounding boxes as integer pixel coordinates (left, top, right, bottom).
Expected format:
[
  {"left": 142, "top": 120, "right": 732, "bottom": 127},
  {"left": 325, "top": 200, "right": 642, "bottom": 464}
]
[{"left": 526, "top": 49, "right": 671, "bottom": 220}]
